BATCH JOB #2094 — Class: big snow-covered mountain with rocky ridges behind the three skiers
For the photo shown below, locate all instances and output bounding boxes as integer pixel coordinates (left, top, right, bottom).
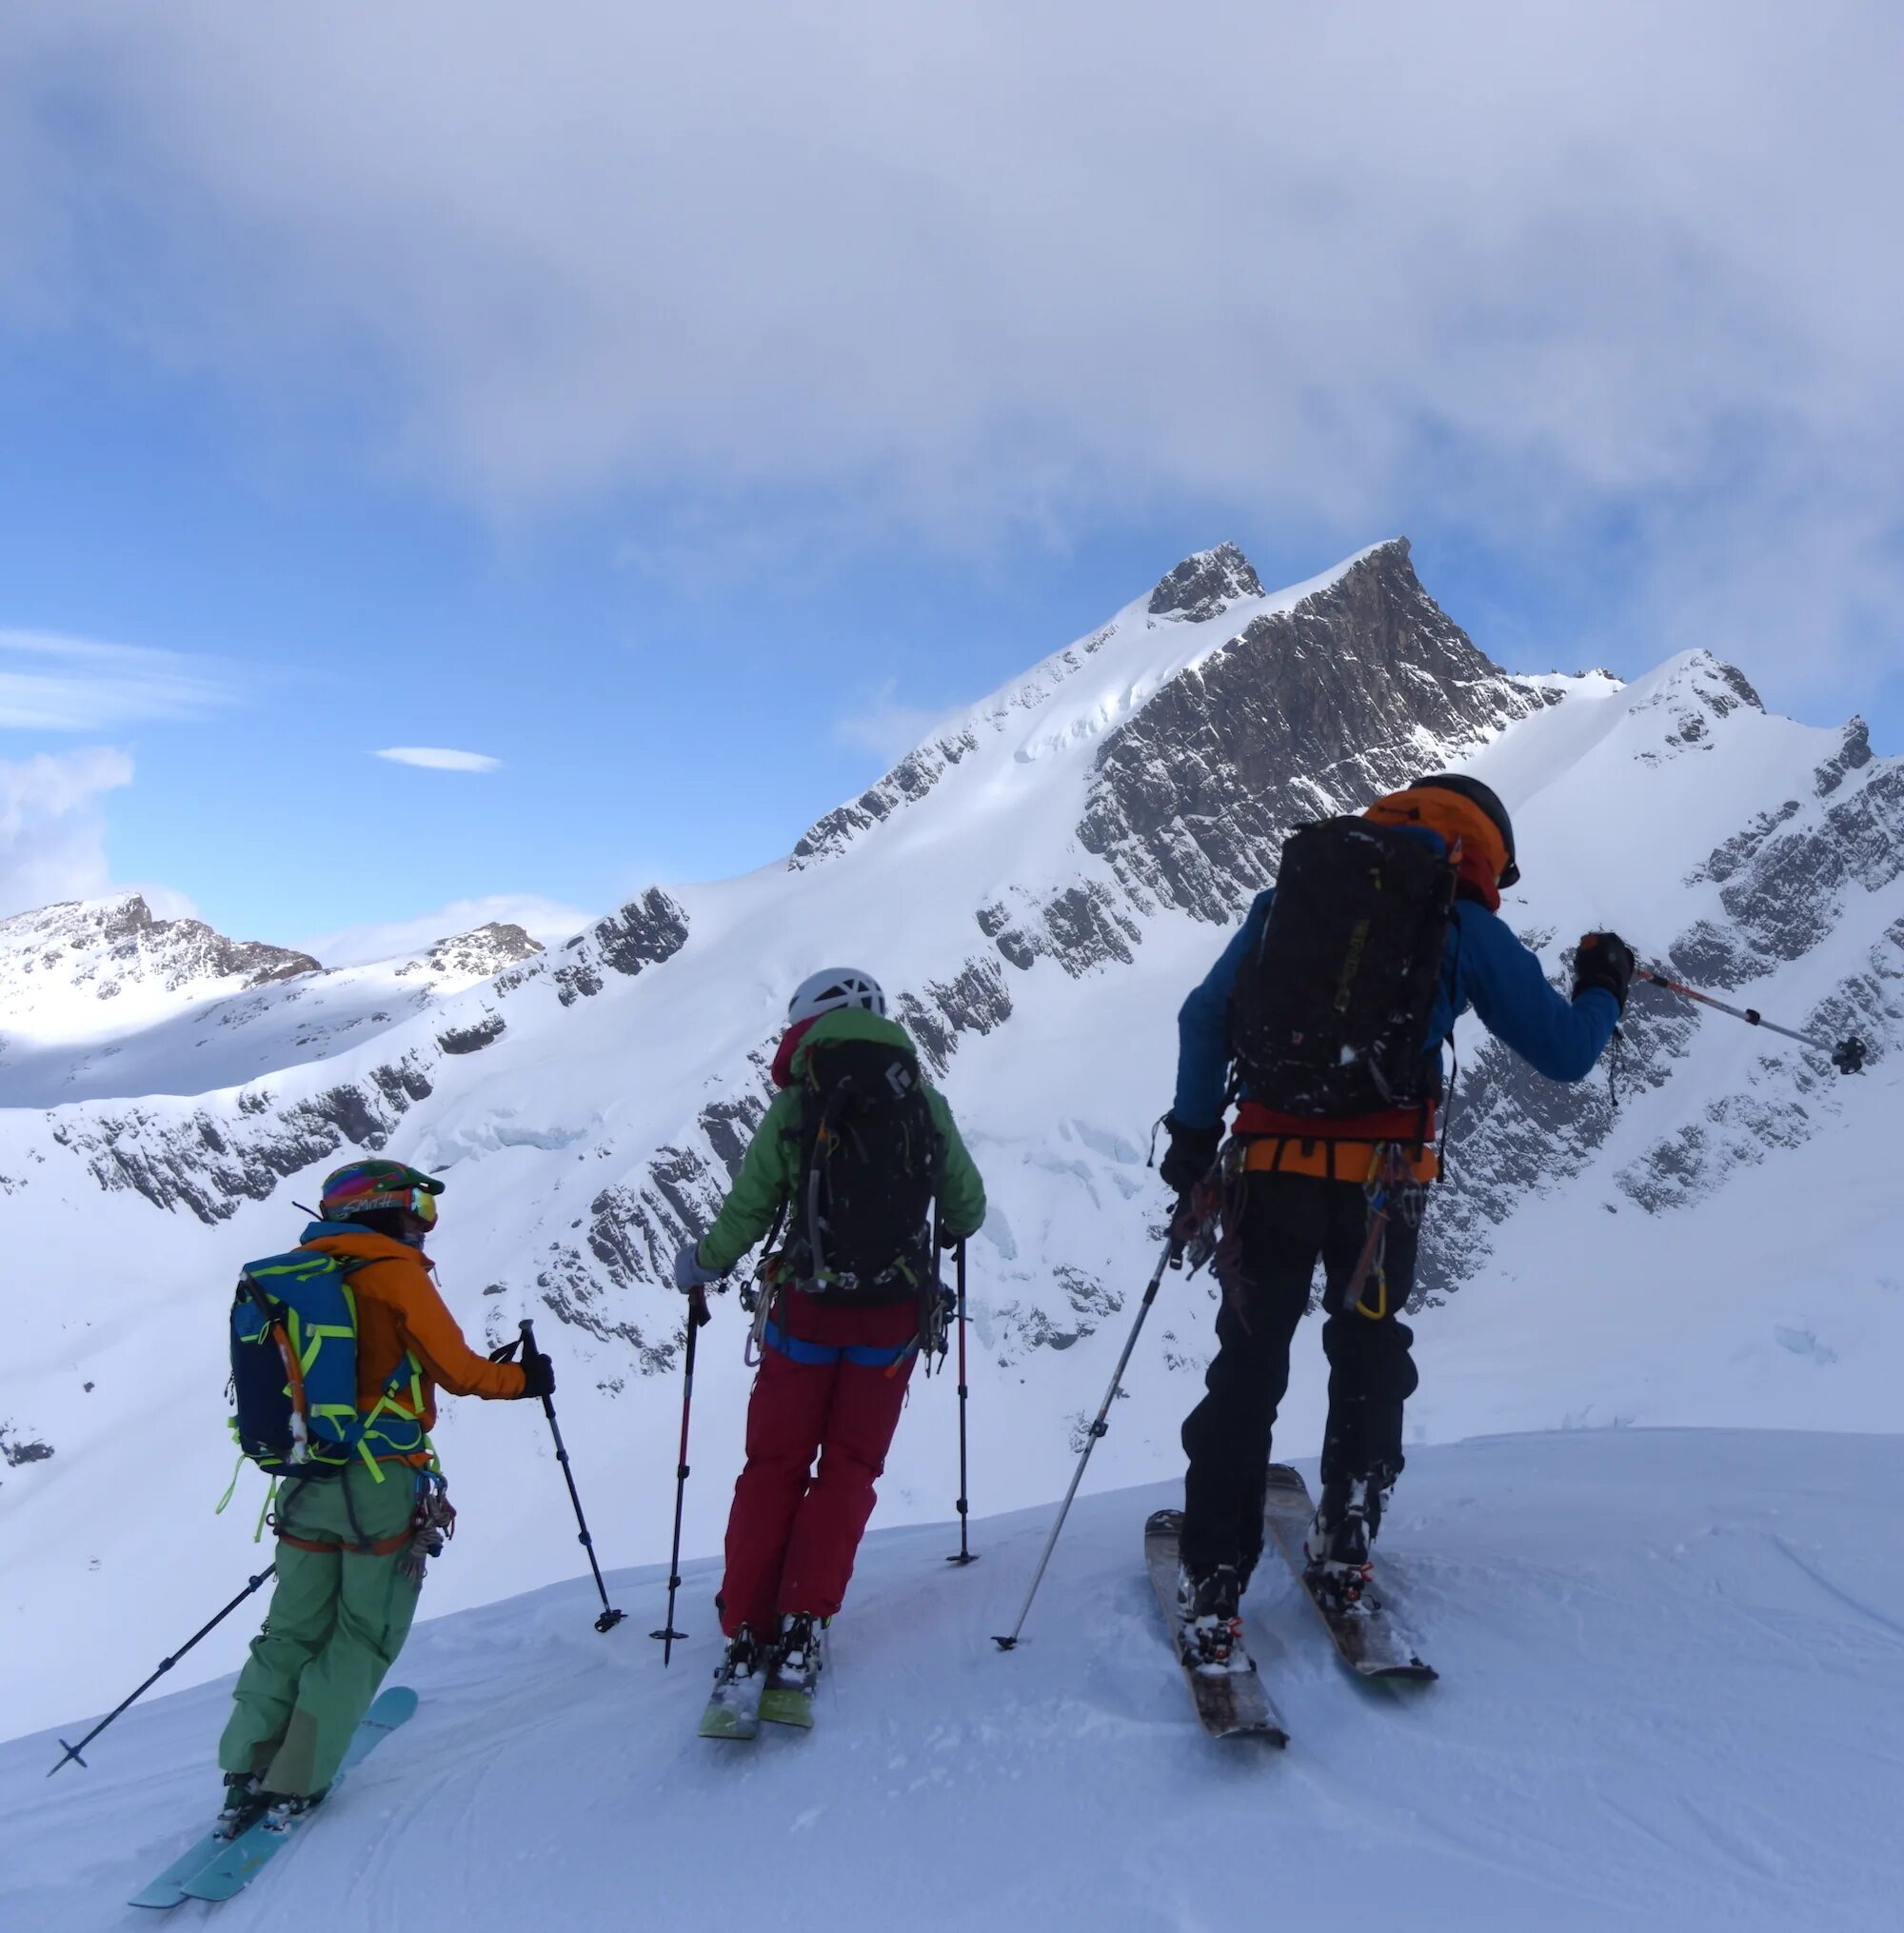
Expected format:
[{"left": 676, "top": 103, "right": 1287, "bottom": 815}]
[{"left": 0, "top": 541, "right": 1904, "bottom": 1747}]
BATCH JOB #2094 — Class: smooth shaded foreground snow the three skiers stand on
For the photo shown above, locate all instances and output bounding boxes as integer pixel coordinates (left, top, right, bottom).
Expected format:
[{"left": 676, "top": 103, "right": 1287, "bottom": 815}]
[{"left": 0, "top": 1430, "right": 1904, "bottom": 1933}]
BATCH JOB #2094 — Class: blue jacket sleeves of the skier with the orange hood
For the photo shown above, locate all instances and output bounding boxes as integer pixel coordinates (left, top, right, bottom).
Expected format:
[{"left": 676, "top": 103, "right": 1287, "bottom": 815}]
[{"left": 1171, "top": 887, "right": 1620, "bottom": 1126}]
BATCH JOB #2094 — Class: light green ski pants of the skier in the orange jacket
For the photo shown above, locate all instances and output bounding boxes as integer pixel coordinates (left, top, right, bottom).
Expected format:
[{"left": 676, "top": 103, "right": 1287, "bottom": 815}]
[{"left": 218, "top": 1464, "right": 418, "bottom": 1796}]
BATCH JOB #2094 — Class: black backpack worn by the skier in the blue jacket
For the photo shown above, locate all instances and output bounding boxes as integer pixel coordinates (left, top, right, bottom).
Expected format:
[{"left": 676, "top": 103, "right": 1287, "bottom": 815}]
[{"left": 1229, "top": 820, "right": 1456, "bottom": 1119}]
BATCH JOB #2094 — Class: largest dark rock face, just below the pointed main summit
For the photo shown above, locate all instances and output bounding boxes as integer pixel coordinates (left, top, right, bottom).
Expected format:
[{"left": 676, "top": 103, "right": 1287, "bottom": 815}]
[{"left": 1074, "top": 539, "right": 1550, "bottom": 924}]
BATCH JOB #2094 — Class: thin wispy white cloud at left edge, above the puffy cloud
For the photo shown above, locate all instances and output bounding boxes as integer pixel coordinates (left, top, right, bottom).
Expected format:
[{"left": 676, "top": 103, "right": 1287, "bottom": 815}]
[{"left": 0, "top": 630, "right": 236, "bottom": 732}]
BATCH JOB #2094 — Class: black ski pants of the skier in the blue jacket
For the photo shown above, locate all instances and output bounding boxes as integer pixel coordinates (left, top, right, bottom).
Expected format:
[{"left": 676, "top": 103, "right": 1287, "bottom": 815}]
[{"left": 1180, "top": 1173, "right": 1420, "bottom": 1582}]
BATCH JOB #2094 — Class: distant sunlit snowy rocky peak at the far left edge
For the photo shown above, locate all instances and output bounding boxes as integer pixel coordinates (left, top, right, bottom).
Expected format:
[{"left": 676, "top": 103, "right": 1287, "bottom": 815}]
[{"left": 0, "top": 893, "right": 321, "bottom": 1036}]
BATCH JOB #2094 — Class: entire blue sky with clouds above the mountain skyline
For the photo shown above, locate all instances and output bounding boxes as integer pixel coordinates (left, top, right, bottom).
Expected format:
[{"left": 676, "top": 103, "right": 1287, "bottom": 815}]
[{"left": 0, "top": 0, "right": 1904, "bottom": 957}]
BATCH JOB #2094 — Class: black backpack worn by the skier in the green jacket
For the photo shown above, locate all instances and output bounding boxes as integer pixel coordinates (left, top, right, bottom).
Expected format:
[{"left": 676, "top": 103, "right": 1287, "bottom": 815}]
[{"left": 786, "top": 1040, "right": 945, "bottom": 1301}]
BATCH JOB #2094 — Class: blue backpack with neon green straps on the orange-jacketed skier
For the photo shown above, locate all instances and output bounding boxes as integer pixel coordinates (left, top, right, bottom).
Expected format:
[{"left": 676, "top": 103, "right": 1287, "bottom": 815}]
[{"left": 232, "top": 1248, "right": 429, "bottom": 1483}]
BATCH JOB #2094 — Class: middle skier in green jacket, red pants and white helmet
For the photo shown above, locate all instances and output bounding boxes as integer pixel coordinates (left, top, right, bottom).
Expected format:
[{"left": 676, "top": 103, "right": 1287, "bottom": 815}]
[{"left": 675, "top": 968, "right": 986, "bottom": 1680}]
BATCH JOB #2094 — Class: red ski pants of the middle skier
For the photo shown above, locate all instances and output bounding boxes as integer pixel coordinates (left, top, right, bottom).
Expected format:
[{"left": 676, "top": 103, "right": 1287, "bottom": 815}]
[{"left": 719, "top": 1291, "right": 918, "bottom": 1637}]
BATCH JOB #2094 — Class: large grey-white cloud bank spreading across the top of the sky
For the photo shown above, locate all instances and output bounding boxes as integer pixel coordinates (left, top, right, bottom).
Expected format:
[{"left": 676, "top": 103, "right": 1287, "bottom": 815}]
[{"left": 0, "top": 0, "right": 1904, "bottom": 674}]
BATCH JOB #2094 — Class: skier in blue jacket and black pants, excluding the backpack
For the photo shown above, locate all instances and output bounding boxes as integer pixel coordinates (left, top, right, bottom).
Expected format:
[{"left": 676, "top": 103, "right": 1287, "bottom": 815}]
[{"left": 1161, "top": 773, "right": 1636, "bottom": 1657}]
